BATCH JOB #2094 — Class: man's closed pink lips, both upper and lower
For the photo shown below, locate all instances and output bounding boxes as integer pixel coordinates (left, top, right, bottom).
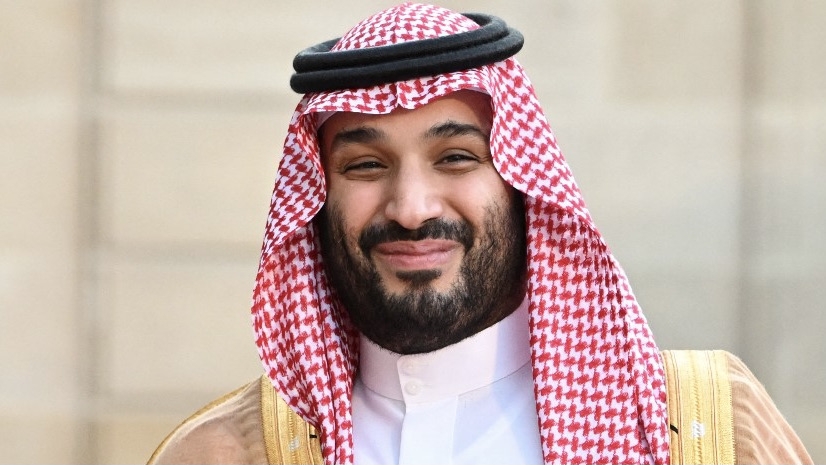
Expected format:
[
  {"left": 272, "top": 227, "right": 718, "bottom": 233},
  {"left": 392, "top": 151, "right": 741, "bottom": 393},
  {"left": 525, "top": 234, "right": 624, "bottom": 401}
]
[{"left": 373, "top": 239, "right": 461, "bottom": 270}]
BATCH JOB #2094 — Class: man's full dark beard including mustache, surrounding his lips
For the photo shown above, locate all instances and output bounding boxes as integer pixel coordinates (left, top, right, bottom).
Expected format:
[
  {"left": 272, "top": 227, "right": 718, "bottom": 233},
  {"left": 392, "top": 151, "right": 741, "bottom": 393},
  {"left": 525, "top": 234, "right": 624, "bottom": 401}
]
[{"left": 315, "top": 189, "right": 527, "bottom": 354}]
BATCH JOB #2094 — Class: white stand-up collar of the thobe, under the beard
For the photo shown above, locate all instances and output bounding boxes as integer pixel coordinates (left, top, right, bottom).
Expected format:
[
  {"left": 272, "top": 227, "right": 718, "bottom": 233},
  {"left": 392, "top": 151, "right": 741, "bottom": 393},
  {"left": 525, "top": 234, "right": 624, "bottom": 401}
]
[{"left": 359, "top": 299, "right": 530, "bottom": 403}]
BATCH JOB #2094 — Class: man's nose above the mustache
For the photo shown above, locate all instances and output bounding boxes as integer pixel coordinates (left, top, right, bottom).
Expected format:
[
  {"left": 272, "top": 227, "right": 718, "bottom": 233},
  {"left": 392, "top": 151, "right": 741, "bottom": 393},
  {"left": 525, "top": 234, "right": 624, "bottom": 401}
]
[{"left": 384, "top": 167, "right": 444, "bottom": 229}]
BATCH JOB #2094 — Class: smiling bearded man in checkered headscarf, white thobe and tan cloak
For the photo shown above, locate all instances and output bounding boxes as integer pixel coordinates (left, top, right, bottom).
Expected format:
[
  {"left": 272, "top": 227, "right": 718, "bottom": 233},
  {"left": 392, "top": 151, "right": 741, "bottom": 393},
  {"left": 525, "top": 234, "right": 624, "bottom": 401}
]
[{"left": 151, "top": 4, "right": 810, "bottom": 464}]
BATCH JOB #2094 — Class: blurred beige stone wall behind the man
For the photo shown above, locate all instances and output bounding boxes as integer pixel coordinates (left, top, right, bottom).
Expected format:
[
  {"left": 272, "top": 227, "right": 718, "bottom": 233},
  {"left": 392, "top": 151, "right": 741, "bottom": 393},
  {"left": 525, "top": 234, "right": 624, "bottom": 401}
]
[{"left": 0, "top": 0, "right": 826, "bottom": 464}]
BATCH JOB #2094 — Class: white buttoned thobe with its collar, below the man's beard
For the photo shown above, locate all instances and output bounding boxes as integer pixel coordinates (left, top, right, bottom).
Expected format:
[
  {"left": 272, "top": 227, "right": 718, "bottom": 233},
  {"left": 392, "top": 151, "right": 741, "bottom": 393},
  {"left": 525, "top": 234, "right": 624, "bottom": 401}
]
[{"left": 353, "top": 301, "right": 542, "bottom": 465}]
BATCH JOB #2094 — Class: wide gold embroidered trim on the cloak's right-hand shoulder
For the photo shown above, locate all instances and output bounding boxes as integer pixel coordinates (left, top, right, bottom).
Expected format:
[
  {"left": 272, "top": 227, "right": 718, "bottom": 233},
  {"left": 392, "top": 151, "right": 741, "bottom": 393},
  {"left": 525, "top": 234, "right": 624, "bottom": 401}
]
[{"left": 662, "top": 350, "right": 735, "bottom": 464}]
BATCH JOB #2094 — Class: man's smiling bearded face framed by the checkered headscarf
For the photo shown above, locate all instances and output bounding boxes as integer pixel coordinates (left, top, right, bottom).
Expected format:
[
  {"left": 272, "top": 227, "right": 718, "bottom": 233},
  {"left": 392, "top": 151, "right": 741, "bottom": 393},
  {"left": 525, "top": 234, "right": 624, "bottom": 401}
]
[{"left": 317, "top": 91, "right": 526, "bottom": 353}]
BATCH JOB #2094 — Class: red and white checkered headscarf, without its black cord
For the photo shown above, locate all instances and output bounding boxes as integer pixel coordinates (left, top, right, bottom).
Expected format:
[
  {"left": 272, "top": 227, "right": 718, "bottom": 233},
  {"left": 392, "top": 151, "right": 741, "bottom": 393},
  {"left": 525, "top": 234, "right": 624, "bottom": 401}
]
[{"left": 252, "top": 4, "right": 669, "bottom": 464}]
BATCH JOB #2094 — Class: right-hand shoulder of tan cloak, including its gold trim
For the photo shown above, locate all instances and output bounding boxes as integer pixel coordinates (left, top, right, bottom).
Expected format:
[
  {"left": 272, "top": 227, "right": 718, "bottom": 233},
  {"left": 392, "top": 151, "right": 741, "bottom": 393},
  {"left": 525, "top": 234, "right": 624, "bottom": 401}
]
[{"left": 662, "top": 350, "right": 812, "bottom": 464}]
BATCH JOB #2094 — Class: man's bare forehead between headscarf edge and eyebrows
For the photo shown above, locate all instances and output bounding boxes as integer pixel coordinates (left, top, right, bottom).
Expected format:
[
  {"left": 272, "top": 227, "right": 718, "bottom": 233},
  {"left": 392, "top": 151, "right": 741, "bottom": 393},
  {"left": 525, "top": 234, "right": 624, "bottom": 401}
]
[{"left": 318, "top": 90, "right": 493, "bottom": 141}]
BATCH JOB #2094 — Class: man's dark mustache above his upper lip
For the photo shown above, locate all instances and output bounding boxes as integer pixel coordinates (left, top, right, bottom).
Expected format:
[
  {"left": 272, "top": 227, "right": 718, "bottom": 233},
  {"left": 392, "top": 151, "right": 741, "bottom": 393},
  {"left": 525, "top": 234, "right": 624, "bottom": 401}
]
[{"left": 359, "top": 219, "right": 473, "bottom": 255}]
